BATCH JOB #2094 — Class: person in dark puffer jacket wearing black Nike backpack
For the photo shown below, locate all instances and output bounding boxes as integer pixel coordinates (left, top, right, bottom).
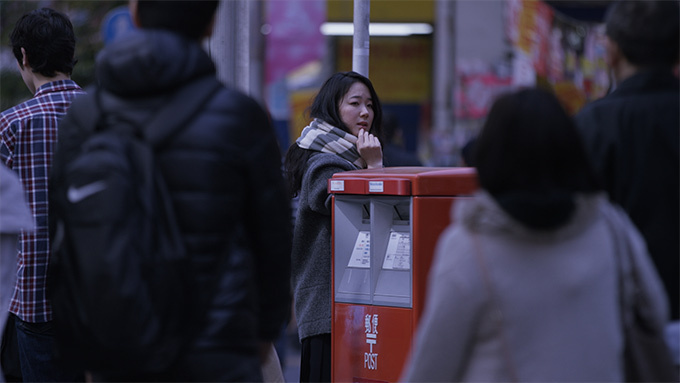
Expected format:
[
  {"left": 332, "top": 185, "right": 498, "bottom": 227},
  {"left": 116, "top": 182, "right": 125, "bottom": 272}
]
[{"left": 50, "top": 0, "right": 291, "bottom": 381}]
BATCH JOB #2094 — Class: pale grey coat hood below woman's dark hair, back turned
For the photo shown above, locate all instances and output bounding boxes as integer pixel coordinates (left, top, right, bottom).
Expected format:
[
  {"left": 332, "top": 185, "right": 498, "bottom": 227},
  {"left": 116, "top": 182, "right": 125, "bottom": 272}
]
[{"left": 452, "top": 190, "right": 606, "bottom": 240}]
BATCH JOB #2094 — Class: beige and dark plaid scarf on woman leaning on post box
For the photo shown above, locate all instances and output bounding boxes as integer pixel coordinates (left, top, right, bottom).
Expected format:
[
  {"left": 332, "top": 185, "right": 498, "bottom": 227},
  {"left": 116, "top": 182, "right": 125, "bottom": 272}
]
[{"left": 295, "top": 118, "right": 366, "bottom": 169}]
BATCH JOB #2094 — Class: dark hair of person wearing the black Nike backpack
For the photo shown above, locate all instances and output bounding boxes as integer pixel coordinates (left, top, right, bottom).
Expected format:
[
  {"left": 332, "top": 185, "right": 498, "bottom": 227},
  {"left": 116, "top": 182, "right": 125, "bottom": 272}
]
[{"left": 137, "top": 0, "right": 219, "bottom": 40}]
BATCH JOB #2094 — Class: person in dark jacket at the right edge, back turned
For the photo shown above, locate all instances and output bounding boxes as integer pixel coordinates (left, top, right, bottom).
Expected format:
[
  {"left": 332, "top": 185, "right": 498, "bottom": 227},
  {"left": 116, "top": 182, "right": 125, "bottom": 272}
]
[{"left": 576, "top": 0, "right": 680, "bottom": 365}]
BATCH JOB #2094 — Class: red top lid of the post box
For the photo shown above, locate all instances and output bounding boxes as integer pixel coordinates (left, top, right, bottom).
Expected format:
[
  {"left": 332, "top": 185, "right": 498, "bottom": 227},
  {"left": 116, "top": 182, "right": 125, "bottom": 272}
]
[{"left": 328, "top": 166, "right": 478, "bottom": 196}]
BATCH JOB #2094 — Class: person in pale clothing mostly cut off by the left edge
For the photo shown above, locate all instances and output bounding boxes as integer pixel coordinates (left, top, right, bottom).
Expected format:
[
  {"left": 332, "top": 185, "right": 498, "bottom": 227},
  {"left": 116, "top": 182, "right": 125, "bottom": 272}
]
[{"left": 0, "top": 163, "right": 35, "bottom": 382}]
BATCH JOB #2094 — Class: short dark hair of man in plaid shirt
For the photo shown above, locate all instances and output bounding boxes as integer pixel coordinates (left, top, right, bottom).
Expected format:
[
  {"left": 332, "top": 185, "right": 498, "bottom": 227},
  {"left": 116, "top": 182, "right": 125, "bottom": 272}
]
[{"left": 9, "top": 8, "right": 76, "bottom": 77}]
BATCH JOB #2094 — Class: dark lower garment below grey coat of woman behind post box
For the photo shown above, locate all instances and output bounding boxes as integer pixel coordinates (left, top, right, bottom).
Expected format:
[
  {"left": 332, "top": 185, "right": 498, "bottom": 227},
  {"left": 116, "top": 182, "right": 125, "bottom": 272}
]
[{"left": 300, "top": 334, "right": 331, "bottom": 382}]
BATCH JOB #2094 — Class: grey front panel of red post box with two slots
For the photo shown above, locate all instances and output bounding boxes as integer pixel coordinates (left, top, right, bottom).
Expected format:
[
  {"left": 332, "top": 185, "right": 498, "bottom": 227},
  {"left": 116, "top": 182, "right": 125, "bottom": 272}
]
[{"left": 334, "top": 195, "right": 412, "bottom": 307}]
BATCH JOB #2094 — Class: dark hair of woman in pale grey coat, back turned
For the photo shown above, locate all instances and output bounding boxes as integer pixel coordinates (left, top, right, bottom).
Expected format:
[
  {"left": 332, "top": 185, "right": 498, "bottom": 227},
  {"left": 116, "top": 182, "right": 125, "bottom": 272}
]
[{"left": 473, "top": 88, "right": 601, "bottom": 230}]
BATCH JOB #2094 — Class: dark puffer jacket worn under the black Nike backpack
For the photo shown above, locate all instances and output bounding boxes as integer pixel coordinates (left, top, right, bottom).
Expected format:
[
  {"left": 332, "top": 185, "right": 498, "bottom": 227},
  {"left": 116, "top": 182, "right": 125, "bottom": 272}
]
[{"left": 53, "top": 31, "right": 291, "bottom": 381}]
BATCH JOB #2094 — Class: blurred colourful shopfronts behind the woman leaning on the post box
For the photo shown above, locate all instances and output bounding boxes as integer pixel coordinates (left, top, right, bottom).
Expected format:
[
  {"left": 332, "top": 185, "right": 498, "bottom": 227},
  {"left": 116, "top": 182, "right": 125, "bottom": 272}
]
[{"left": 254, "top": 0, "right": 609, "bottom": 166}]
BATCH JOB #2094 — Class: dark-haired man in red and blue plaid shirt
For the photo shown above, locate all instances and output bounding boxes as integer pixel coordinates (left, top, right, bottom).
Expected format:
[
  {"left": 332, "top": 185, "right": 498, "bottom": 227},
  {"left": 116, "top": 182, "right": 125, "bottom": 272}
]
[{"left": 0, "top": 8, "right": 84, "bottom": 382}]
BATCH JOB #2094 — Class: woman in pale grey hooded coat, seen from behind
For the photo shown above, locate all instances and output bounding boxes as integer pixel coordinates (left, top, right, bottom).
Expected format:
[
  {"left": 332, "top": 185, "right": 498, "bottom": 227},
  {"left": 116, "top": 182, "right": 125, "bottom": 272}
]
[{"left": 402, "top": 89, "right": 667, "bottom": 382}]
